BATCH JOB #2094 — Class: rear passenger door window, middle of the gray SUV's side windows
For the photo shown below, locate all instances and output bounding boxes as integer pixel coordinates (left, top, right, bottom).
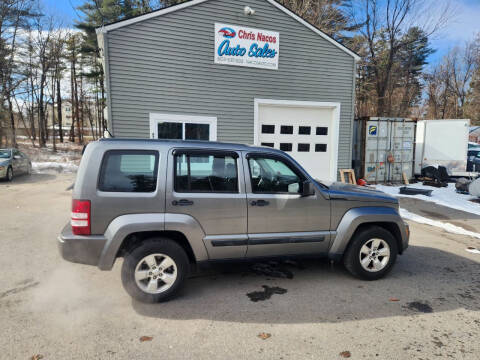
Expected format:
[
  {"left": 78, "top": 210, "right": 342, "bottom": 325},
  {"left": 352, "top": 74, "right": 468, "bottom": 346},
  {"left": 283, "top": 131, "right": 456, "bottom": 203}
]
[{"left": 175, "top": 153, "right": 238, "bottom": 193}]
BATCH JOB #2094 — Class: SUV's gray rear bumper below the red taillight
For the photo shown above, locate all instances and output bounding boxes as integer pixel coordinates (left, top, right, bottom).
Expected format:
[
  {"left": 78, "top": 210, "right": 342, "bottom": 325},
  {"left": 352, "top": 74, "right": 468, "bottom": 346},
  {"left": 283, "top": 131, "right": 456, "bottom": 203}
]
[{"left": 57, "top": 224, "right": 107, "bottom": 265}]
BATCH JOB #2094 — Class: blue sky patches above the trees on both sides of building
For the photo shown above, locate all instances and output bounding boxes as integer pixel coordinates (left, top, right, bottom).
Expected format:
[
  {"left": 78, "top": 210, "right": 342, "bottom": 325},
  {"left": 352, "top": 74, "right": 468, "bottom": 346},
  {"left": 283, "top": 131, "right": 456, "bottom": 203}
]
[{"left": 42, "top": 0, "right": 480, "bottom": 63}]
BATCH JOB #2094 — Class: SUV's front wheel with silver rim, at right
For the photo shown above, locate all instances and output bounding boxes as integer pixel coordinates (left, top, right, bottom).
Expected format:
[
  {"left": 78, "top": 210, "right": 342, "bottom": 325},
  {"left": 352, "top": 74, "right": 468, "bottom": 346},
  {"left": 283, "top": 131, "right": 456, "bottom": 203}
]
[{"left": 343, "top": 226, "right": 398, "bottom": 280}]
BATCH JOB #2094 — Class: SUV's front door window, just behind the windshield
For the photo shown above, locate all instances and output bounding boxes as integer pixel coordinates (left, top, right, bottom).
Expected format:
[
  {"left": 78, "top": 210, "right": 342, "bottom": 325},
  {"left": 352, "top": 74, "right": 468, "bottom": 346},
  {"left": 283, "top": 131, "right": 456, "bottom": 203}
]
[{"left": 248, "top": 156, "right": 304, "bottom": 194}]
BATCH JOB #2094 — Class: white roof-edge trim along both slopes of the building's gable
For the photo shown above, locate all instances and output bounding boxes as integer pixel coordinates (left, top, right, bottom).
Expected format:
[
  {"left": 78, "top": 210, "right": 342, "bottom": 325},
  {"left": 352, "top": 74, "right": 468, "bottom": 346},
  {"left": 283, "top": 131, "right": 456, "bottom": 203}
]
[{"left": 95, "top": 0, "right": 360, "bottom": 61}]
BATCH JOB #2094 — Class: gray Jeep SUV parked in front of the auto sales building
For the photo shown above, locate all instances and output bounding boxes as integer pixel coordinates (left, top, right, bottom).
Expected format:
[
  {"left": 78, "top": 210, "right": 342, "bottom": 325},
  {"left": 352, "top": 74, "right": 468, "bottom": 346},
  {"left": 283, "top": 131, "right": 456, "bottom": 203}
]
[{"left": 58, "top": 139, "right": 409, "bottom": 302}]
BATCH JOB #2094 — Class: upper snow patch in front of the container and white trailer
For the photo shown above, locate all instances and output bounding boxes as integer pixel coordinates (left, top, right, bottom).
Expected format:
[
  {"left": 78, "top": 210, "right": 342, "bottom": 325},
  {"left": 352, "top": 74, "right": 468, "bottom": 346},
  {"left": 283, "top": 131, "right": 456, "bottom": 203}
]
[{"left": 375, "top": 183, "right": 480, "bottom": 215}]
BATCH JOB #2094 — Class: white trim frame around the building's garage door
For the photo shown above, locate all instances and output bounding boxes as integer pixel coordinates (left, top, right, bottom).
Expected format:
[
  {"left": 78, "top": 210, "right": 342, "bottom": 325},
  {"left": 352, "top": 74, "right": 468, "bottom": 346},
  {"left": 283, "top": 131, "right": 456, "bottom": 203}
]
[{"left": 253, "top": 98, "right": 341, "bottom": 181}]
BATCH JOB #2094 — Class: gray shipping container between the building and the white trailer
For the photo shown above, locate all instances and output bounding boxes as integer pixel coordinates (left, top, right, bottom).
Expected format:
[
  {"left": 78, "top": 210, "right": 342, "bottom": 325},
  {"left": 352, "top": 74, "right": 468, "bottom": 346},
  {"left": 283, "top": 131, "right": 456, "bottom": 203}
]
[{"left": 353, "top": 117, "right": 415, "bottom": 183}]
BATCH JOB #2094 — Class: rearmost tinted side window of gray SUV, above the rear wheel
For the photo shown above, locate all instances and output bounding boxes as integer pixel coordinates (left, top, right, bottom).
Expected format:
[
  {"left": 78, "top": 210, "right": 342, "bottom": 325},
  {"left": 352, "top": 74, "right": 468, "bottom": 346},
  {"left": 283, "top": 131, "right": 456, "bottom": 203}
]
[{"left": 98, "top": 150, "right": 158, "bottom": 193}]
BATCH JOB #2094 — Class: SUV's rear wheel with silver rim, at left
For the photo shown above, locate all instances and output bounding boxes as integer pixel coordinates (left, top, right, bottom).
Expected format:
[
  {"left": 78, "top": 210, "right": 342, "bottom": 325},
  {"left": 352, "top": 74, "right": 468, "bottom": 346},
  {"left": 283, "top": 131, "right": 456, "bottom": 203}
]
[{"left": 122, "top": 238, "right": 190, "bottom": 303}]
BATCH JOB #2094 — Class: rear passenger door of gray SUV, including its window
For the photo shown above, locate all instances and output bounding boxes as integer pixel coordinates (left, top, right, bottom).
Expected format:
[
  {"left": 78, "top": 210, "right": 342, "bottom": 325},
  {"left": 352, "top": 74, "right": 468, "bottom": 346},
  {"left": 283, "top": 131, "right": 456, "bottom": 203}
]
[{"left": 166, "top": 149, "right": 248, "bottom": 259}]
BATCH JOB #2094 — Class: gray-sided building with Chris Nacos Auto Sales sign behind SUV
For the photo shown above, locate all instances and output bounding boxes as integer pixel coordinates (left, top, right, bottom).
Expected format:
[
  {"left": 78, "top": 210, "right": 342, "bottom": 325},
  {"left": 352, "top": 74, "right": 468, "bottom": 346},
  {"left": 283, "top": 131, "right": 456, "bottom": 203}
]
[{"left": 97, "top": 0, "right": 358, "bottom": 180}]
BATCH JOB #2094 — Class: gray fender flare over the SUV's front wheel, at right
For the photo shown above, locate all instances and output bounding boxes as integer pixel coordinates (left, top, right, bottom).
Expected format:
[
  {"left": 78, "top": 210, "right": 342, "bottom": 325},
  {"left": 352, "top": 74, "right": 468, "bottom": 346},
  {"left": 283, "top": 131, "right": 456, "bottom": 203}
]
[{"left": 328, "top": 206, "right": 408, "bottom": 260}]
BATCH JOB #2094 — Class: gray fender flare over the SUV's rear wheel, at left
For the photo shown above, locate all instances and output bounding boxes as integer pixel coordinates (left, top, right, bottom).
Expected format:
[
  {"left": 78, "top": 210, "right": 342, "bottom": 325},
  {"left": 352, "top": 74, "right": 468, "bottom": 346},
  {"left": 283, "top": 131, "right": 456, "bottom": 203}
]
[{"left": 98, "top": 213, "right": 208, "bottom": 270}]
